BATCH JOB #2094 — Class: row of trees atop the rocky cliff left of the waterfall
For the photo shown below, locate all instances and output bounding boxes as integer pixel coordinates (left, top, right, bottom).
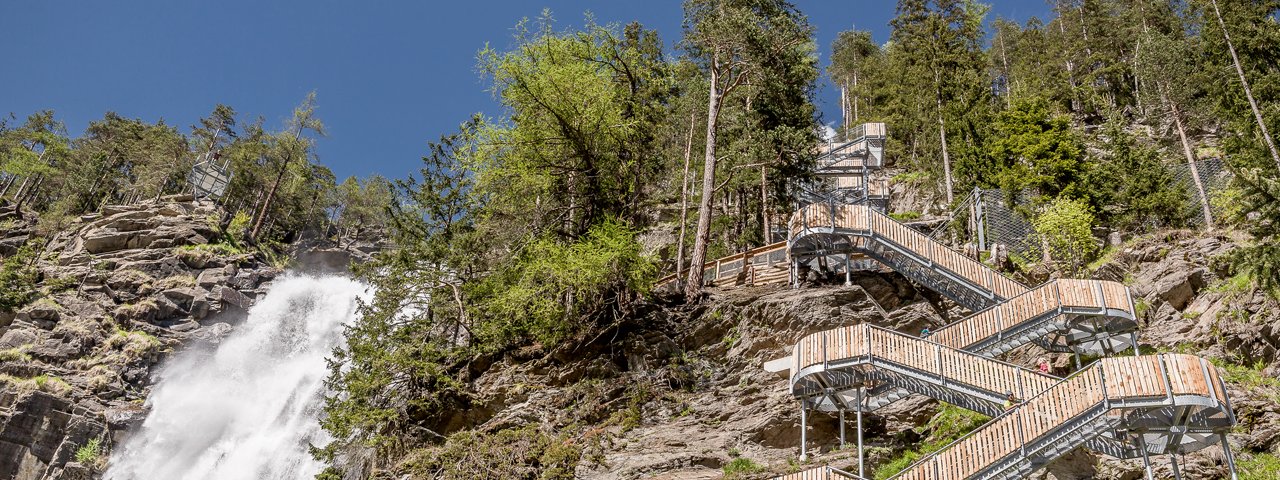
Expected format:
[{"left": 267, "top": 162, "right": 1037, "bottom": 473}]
[{"left": 0, "top": 93, "right": 392, "bottom": 250}]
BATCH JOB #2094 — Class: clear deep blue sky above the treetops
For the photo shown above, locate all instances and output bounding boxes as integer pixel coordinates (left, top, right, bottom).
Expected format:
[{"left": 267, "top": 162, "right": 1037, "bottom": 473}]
[{"left": 0, "top": 0, "right": 1048, "bottom": 179}]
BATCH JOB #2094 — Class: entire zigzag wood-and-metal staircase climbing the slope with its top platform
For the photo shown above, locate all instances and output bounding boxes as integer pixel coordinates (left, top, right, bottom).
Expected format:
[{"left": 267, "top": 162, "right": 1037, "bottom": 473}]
[{"left": 660, "top": 124, "right": 1236, "bottom": 480}]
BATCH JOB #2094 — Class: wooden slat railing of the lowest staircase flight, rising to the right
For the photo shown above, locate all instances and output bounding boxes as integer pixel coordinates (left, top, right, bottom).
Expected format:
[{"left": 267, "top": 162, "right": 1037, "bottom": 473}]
[{"left": 893, "top": 353, "right": 1228, "bottom": 480}]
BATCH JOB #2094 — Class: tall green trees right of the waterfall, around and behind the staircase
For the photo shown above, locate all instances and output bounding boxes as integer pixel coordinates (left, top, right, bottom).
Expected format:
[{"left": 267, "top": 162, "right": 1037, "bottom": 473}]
[{"left": 312, "top": 0, "right": 1280, "bottom": 477}]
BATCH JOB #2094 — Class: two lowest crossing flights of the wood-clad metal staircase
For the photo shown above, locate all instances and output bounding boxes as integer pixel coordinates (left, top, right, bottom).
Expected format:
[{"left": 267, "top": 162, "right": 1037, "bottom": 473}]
[{"left": 787, "top": 324, "right": 1235, "bottom": 479}]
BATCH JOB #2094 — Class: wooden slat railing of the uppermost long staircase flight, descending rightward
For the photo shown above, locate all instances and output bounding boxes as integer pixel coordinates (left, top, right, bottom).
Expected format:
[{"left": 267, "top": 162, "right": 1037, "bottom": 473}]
[{"left": 788, "top": 204, "right": 1027, "bottom": 298}]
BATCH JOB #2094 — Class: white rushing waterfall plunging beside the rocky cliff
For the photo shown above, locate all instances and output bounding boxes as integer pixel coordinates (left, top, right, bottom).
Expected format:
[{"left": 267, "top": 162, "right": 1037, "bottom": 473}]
[{"left": 106, "top": 275, "right": 367, "bottom": 480}]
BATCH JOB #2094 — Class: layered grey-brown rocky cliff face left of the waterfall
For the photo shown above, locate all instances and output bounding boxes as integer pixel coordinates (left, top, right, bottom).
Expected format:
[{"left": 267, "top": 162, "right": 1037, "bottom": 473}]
[{"left": 0, "top": 196, "right": 280, "bottom": 480}]
